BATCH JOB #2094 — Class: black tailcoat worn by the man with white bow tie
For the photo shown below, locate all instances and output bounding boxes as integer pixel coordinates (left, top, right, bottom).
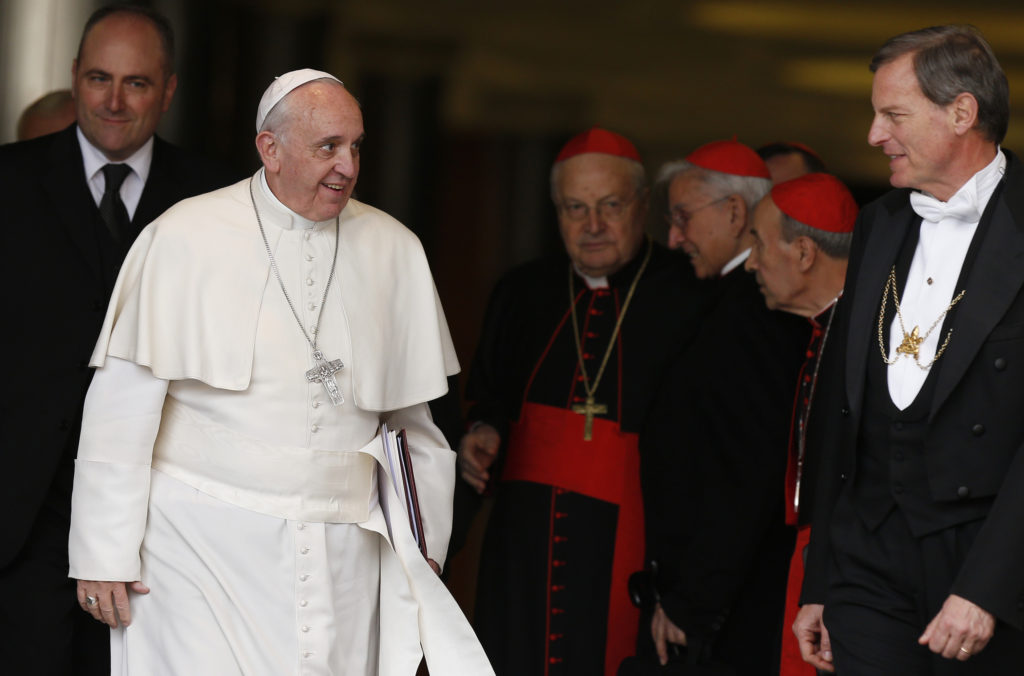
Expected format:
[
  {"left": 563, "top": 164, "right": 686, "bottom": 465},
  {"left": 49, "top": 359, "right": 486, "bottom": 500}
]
[{"left": 802, "top": 151, "right": 1024, "bottom": 628}]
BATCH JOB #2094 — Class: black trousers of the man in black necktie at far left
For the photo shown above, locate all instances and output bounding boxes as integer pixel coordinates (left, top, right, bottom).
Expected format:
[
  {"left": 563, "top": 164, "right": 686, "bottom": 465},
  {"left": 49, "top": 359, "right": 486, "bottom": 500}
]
[{"left": 0, "top": 505, "right": 111, "bottom": 676}]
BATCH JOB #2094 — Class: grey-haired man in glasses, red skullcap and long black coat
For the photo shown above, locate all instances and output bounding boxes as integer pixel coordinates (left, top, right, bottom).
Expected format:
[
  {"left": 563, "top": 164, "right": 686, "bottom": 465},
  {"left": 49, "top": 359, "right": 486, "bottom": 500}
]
[{"left": 638, "top": 140, "right": 810, "bottom": 676}]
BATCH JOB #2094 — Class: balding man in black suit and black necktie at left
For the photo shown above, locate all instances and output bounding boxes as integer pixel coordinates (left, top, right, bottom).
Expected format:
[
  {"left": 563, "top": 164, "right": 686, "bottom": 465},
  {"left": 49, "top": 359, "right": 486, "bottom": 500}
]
[{"left": 0, "top": 5, "right": 234, "bottom": 674}]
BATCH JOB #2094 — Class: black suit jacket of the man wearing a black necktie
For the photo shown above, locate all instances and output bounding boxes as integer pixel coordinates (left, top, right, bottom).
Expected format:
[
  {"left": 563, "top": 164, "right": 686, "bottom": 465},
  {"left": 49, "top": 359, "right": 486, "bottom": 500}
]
[{"left": 0, "top": 125, "right": 231, "bottom": 568}]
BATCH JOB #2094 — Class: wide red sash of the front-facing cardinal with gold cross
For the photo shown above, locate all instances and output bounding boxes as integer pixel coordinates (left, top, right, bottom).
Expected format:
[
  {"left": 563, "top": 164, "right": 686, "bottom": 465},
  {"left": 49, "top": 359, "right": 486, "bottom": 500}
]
[{"left": 502, "top": 403, "right": 644, "bottom": 676}]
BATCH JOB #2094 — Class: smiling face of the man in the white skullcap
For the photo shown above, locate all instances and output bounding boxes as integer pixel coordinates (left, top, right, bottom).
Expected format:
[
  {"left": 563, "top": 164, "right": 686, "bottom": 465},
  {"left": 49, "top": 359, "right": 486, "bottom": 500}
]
[{"left": 262, "top": 82, "right": 364, "bottom": 221}]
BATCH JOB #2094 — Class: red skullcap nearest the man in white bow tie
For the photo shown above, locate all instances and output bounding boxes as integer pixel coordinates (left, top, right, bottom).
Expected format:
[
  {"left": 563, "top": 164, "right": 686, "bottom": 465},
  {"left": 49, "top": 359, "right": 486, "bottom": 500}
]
[{"left": 771, "top": 174, "right": 858, "bottom": 233}]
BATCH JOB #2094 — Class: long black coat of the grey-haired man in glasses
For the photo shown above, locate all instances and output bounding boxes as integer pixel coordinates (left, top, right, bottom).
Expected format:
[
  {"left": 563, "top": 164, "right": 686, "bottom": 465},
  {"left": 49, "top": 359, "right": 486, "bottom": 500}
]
[{"left": 640, "top": 268, "right": 811, "bottom": 674}]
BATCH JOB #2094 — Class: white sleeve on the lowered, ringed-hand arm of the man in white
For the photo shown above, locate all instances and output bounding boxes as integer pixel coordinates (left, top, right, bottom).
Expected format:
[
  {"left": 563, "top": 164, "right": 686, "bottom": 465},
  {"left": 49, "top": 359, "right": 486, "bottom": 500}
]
[{"left": 68, "top": 357, "right": 167, "bottom": 582}]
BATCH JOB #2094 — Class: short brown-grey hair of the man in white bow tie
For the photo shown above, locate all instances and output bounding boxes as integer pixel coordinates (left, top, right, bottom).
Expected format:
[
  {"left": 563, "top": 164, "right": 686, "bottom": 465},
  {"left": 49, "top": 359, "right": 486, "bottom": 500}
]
[{"left": 870, "top": 26, "right": 1010, "bottom": 143}]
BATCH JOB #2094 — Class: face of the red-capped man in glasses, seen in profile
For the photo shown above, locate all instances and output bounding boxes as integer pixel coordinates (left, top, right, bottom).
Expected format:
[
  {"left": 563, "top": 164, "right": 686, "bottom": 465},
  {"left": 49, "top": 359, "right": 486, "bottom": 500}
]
[{"left": 669, "top": 171, "right": 741, "bottom": 280}]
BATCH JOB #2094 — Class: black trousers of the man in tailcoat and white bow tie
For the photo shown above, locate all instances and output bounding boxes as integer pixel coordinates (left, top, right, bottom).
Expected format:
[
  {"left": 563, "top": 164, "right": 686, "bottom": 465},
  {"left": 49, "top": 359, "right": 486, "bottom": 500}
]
[{"left": 824, "top": 492, "right": 1024, "bottom": 676}]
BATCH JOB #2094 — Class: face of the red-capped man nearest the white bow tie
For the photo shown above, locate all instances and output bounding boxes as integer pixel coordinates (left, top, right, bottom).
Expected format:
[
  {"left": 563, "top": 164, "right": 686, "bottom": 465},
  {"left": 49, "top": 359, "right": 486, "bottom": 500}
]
[{"left": 745, "top": 195, "right": 804, "bottom": 310}]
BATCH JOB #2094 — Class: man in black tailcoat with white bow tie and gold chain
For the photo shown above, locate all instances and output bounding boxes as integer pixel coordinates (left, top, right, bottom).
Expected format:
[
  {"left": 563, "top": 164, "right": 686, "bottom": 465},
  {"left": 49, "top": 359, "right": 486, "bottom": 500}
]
[{"left": 794, "top": 26, "right": 1024, "bottom": 676}]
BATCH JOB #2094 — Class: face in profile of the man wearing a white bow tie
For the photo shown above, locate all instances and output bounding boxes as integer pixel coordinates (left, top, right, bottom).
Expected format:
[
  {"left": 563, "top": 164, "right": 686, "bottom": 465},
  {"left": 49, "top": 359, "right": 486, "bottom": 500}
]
[{"left": 867, "top": 54, "right": 959, "bottom": 200}]
